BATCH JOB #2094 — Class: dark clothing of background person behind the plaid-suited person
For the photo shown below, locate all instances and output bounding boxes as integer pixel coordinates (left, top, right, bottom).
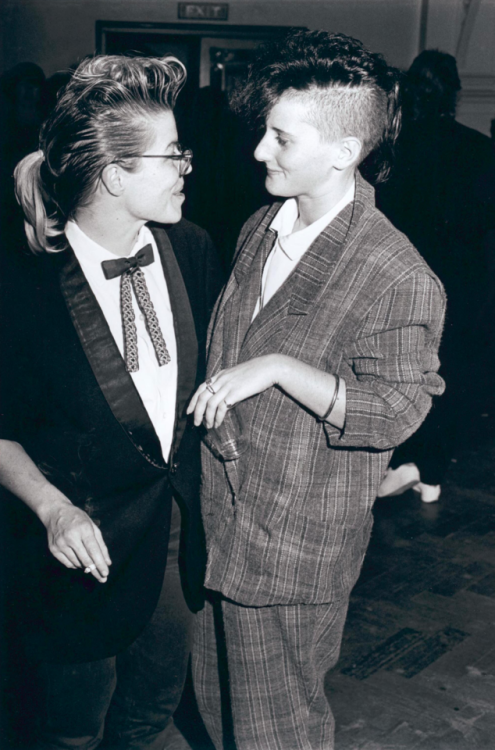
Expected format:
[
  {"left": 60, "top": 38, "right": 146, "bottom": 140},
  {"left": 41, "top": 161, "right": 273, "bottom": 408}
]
[{"left": 377, "top": 117, "right": 495, "bottom": 485}]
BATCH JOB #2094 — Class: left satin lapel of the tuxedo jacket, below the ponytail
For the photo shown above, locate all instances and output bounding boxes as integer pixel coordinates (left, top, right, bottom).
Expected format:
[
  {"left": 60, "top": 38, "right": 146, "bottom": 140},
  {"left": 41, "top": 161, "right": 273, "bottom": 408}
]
[{"left": 59, "top": 248, "right": 165, "bottom": 468}]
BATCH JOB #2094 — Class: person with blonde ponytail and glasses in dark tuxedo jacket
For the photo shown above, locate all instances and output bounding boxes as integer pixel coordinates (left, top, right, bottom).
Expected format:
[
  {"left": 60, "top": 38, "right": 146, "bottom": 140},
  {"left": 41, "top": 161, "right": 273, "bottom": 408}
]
[{"left": 0, "top": 56, "right": 220, "bottom": 750}]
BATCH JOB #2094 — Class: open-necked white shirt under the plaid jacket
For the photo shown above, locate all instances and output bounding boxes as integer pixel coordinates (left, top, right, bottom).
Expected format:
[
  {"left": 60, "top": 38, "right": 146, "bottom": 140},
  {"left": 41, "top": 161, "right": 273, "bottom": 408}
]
[{"left": 252, "top": 183, "right": 355, "bottom": 320}]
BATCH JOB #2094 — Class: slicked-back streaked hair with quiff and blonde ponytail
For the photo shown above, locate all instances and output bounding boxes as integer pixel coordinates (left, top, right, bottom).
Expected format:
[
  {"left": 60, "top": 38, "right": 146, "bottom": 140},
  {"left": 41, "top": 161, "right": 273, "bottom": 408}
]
[{"left": 14, "top": 55, "right": 186, "bottom": 252}]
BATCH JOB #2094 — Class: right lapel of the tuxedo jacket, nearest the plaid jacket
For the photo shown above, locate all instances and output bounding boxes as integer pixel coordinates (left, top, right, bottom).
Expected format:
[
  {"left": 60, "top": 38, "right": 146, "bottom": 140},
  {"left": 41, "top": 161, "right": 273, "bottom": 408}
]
[{"left": 151, "top": 227, "right": 198, "bottom": 453}]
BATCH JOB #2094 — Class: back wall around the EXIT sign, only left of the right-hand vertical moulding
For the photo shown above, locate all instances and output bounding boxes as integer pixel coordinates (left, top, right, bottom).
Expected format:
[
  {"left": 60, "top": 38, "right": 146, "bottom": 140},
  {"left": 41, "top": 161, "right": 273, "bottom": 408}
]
[{"left": 3, "top": 0, "right": 421, "bottom": 75}]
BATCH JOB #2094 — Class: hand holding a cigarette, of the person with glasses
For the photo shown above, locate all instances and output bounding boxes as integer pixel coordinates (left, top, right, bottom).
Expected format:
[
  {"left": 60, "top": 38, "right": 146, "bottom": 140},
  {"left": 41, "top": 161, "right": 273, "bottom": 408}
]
[{"left": 40, "top": 500, "right": 112, "bottom": 583}]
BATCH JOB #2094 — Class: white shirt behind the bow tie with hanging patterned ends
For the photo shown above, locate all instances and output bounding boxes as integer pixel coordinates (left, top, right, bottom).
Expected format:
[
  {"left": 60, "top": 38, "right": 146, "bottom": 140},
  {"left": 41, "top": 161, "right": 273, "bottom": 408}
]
[{"left": 65, "top": 221, "right": 177, "bottom": 461}]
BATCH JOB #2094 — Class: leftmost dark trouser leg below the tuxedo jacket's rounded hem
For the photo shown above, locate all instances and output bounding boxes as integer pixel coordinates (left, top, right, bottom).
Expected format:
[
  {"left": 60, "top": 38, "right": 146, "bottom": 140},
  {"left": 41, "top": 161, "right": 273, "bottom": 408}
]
[{"left": 35, "top": 658, "right": 116, "bottom": 750}]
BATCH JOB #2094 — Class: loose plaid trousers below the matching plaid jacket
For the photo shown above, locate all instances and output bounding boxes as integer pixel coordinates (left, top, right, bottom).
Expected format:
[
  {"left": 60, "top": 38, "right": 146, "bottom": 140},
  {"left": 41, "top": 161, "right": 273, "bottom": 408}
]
[{"left": 193, "top": 594, "right": 348, "bottom": 750}]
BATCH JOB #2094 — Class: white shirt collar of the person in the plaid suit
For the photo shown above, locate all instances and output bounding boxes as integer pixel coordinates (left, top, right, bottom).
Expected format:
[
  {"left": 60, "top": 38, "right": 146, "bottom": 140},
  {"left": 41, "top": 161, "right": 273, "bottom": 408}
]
[{"left": 269, "top": 182, "right": 356, "bottom": 260}]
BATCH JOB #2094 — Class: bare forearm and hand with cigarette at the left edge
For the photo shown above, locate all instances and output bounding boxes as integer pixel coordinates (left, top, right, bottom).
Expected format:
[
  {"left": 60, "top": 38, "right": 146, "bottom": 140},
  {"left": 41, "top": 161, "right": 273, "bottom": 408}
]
[{"left": 0, "top": 440, "right": 111, "bottom": 583}]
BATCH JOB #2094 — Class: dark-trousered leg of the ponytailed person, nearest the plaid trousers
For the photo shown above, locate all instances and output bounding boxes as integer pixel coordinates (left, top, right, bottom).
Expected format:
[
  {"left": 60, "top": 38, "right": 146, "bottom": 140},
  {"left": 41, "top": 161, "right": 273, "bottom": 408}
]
[{"left": 102, "top": 502, "right": 194, "bottom": 750}]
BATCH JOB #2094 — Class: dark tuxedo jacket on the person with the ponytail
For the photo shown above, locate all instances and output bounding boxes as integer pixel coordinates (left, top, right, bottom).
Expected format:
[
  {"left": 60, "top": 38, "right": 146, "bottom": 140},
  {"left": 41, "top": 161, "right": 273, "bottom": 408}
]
[{"left": 2, "top": 220, "right": 221, "bottom": 661}]
